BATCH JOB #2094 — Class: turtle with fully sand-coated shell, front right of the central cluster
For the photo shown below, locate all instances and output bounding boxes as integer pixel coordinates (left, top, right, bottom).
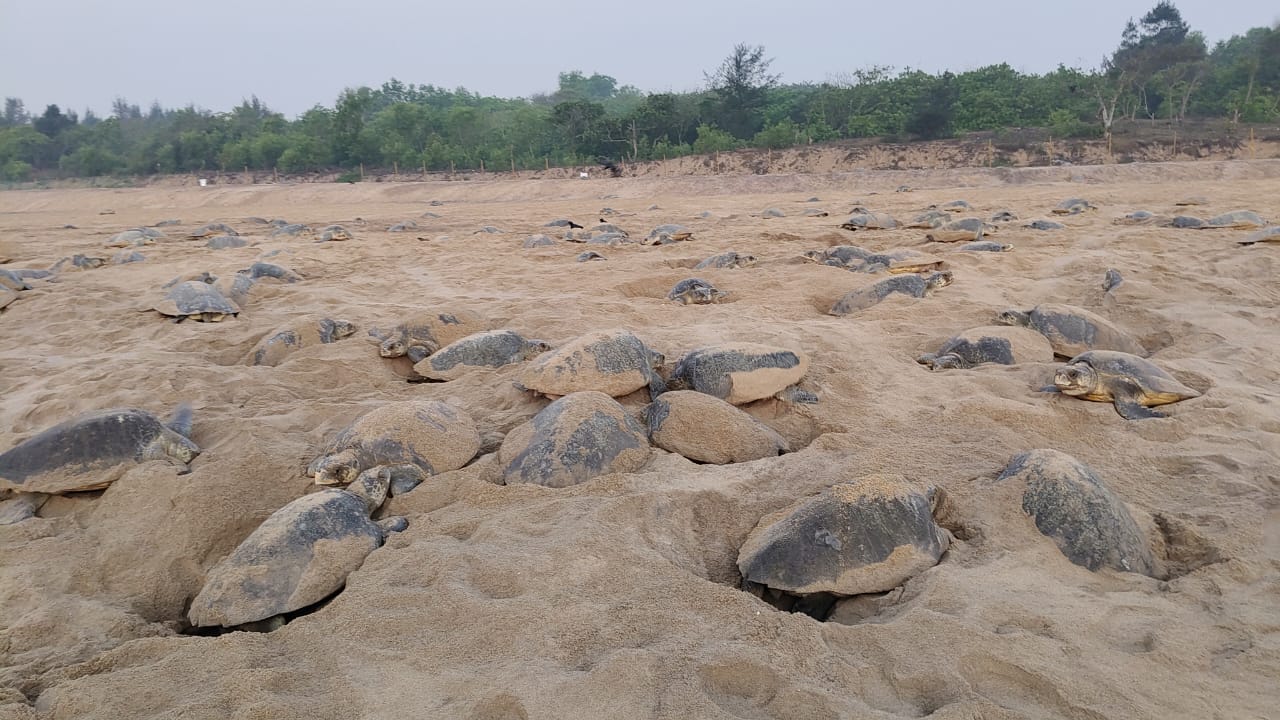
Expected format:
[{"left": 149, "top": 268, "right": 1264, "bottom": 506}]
[{"left": 641, "top": 389, "right": 788, "bottom": 465}]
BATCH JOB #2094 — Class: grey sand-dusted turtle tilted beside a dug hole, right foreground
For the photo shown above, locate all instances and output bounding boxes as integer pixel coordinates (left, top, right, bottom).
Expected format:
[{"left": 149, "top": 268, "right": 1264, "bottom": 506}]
[{"left": 996, "top": 448, "right": 1156, "bottom": 575}]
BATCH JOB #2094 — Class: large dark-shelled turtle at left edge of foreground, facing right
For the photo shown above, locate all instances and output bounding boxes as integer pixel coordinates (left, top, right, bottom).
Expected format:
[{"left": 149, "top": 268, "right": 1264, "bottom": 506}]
[{"left": 0, "top": 404, "right": 200, "bottom": 520}]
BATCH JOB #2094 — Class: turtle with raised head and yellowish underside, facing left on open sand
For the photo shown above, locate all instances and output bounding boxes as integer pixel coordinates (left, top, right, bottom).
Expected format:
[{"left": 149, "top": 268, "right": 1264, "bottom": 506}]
[{"left": 1046, "top": 350, "right": 1201, "bottom": 420}]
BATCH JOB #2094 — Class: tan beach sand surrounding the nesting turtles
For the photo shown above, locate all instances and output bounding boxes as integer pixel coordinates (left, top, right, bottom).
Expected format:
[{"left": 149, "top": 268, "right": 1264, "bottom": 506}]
[{"left": 0, "top": 160, "right": 1280, "bottom": 720}]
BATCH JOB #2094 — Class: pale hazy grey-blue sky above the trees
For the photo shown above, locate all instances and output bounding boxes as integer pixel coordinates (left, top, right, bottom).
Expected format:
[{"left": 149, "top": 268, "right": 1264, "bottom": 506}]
[{"left": 0, "top": 0, "right": 1280, "bottom": 118}]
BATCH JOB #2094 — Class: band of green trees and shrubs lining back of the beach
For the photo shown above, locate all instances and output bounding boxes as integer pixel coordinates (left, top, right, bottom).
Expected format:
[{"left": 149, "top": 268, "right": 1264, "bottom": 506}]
[{"left": 0, "top": 0, "right": 1280, "bottom": 182}]
